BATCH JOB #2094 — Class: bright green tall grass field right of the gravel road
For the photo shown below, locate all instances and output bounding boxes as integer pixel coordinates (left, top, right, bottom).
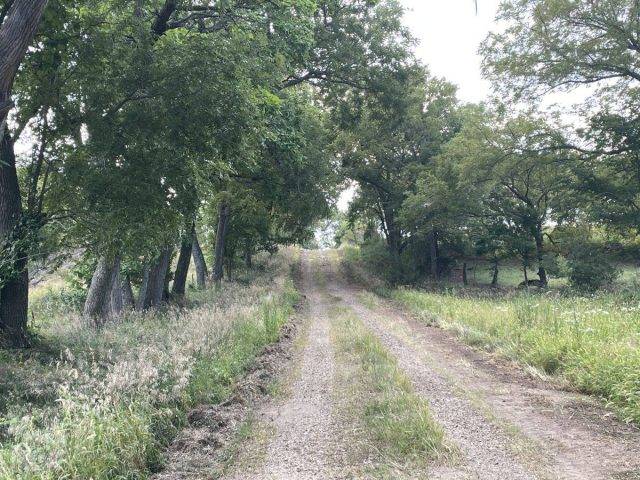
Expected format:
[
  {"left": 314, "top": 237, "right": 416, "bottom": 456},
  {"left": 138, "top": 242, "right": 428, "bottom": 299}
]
[{"left": 391, "top": 289, "right": 640, "bottom": 424}]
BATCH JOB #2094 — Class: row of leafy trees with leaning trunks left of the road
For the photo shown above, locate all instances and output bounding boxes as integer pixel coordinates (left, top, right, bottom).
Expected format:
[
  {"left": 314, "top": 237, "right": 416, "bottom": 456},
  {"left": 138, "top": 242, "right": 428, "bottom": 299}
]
[{"left": 0, "top": 0, "right": 415, "bottom": 346}]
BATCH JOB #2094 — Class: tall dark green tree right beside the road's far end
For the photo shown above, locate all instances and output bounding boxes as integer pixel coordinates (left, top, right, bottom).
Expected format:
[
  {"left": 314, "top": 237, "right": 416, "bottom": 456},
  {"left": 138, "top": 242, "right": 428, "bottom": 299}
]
[{"left": 340, "top": 66, "right": 456, "bottom": 266}]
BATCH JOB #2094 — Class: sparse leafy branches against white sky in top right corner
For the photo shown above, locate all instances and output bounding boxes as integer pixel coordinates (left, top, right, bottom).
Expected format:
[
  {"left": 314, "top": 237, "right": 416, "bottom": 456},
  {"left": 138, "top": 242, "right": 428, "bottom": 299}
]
[{"left": 482, "top": 0, "right": 640, "bottom": 97}]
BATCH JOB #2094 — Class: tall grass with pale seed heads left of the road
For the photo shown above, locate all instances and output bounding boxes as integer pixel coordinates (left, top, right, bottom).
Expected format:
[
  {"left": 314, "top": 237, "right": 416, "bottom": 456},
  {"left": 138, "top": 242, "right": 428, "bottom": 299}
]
[{"left": 0, "top": 253, "right": 296, "bottom": 480}]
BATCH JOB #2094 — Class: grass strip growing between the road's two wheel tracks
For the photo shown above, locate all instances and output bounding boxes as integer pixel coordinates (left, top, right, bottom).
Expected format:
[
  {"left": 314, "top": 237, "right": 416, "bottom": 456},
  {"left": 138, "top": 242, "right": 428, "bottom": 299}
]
[{"left": 332, "top": 308, "right": 446, "bottom": 467}]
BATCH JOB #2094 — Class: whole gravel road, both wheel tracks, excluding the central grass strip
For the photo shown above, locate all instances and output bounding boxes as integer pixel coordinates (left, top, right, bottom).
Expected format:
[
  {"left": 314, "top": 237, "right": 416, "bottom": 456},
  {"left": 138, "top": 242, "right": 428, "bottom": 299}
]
[{"left": 202, "top": 253, "right": 640, "bottom": 480}]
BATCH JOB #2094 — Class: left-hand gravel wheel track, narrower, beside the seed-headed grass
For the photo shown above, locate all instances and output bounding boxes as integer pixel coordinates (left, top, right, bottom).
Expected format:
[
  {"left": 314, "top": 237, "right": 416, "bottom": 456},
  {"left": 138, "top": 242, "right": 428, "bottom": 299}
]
[{"left": 224, "top": 254, "right": 342, "bottom": 480}]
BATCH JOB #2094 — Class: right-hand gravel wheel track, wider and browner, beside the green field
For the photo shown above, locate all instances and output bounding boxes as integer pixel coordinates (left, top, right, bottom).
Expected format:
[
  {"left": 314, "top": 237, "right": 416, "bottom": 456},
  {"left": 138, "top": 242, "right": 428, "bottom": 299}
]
[{"left": 328, "top": 262, "right": 640, "bottom": 480}]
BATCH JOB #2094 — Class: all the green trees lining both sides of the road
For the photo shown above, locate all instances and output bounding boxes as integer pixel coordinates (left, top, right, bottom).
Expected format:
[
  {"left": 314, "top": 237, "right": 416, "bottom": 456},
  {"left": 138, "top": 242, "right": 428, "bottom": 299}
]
[{"left": 0, "top": 0, "right": 640, "bottom": 346}]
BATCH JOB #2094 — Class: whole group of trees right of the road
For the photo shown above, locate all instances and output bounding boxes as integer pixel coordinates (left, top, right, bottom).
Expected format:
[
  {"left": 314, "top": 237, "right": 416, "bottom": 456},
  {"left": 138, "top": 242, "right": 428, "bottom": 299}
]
[{"left": 338, "top": 0, "right": 640, "bottom": 289}]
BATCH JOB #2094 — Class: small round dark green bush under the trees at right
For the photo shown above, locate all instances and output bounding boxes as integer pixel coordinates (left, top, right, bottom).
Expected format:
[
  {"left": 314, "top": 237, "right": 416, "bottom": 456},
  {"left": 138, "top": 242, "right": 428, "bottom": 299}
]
[{"left": 567, "top": 243, "right": 620, "bottom": 292}]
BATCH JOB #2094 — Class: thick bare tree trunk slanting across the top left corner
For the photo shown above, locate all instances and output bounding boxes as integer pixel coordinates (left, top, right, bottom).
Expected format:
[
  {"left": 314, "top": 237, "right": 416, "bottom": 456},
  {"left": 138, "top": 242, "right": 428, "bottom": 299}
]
[{"left": 0, "top": 0, "right": 47, "bottom": 139}]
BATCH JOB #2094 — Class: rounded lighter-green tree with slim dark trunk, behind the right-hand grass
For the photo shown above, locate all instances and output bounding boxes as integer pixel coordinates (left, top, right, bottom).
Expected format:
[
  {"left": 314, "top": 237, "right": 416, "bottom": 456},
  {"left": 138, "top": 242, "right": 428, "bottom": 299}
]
[{"left": 441, "top": 110, "right": 575, "bottom": 286}]
